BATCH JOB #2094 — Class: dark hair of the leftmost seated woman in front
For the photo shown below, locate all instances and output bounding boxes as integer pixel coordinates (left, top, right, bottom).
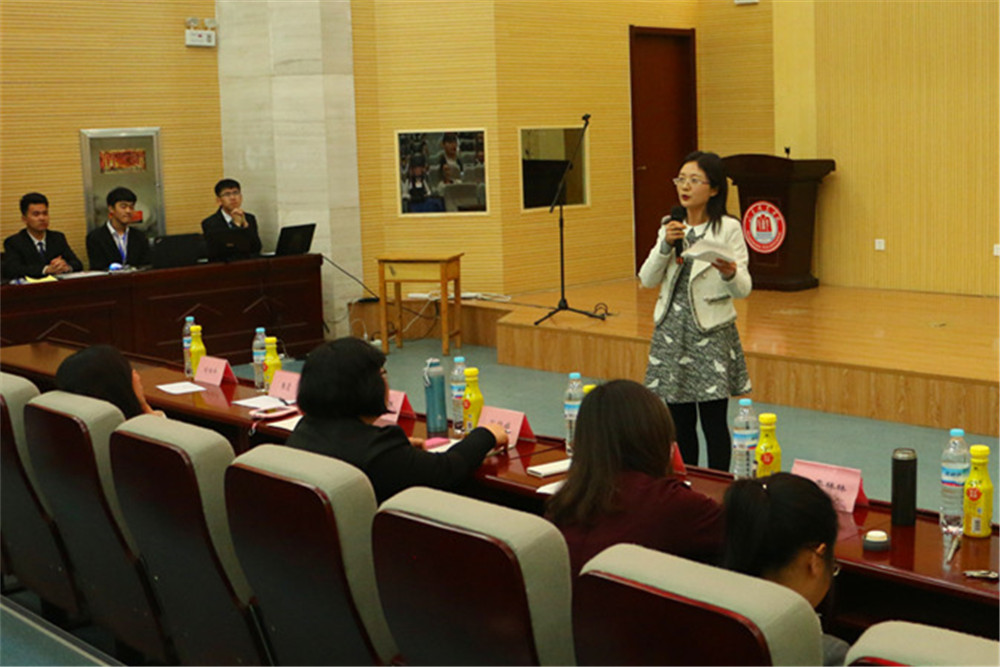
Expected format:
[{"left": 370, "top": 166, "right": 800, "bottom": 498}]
[{"left": 56, "top": 345, "right": 142, "bottom": 419}]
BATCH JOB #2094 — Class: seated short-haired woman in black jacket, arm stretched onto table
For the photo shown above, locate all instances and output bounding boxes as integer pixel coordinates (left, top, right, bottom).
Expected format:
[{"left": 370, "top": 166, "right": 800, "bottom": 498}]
[{"left": 287, "top": 338, "right": 507, "bottom": 503}]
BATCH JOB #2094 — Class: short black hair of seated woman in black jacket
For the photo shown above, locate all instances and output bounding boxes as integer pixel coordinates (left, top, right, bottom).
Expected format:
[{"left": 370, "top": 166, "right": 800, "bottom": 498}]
[{"left": 298, "top": 338, "right": 386, "bottom": 417}]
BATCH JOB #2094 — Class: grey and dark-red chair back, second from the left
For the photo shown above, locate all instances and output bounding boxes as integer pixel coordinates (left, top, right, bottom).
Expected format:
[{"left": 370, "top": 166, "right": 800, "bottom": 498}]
[{"left": 24, "top": 391, "right": 175, "bottom": 663}]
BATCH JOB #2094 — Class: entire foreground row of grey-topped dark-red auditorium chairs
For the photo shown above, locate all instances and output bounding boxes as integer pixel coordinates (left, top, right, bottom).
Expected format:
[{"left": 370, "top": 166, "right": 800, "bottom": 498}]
[{"left": 0, "top": 374, "right": 997, "bottom": 665}]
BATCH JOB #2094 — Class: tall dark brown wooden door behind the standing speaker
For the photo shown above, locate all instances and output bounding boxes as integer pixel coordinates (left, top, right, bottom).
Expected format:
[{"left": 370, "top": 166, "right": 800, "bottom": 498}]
[{"left": 629, "top": 26, "right": 698, "bottom": 271}]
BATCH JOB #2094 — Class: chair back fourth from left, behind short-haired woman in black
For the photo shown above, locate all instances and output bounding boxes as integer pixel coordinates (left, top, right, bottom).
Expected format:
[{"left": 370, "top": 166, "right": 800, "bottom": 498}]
[{"left": 225, "top": 445, "right": 396, "bottom": 665}]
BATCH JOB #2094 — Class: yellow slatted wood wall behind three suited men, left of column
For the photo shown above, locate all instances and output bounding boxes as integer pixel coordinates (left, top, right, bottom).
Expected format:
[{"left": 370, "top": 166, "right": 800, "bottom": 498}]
[{"left": 0, "top": 0, "right": 224, "bottom": 257}]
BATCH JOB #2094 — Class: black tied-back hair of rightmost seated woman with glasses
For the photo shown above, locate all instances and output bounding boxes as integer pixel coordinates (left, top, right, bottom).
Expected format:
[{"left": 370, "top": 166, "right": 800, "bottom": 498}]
[{"left": 722, "top": 472, "right": 837, "bottom": 577}]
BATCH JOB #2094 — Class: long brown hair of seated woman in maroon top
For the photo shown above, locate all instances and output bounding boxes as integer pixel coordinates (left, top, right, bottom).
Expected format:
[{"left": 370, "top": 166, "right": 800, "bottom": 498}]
[{"left": 547, "top": 380, "right": 676, "bottom": 525}]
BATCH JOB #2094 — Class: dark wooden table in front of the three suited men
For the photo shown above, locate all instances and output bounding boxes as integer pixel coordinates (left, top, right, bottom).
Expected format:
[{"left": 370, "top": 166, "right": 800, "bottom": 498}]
[{"left": 0, "top": 255, "right": 323, "bottom": 363}]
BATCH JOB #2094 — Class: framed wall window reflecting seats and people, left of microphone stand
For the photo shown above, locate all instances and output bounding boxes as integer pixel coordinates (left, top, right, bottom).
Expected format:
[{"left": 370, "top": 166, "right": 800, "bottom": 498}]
[{"left": 396, "top": 129, "right": 487, "bottom": 215}]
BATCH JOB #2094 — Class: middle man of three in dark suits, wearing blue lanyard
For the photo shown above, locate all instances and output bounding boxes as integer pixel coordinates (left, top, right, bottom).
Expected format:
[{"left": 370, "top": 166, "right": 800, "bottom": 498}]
[{"left": 87, "top": 188, "right": 152, "bottom": 271}]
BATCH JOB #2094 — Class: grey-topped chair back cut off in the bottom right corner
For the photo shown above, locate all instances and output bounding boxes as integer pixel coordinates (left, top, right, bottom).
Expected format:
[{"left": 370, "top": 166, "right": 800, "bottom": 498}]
[{"left": 844, "top": 621, "right": 1000, "bottom": 665}]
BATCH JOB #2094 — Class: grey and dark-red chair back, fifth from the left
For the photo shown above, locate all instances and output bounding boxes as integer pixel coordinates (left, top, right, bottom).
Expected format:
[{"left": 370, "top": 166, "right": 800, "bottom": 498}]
[{"left": 372, "top": 487, "right": 574, "bottom": 665}]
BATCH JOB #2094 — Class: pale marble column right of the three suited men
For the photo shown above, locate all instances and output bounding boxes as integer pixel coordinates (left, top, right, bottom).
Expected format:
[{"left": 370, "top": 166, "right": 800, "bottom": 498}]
[{"left": 216, "top": 0, "right": 366, "bottom": 337}]
